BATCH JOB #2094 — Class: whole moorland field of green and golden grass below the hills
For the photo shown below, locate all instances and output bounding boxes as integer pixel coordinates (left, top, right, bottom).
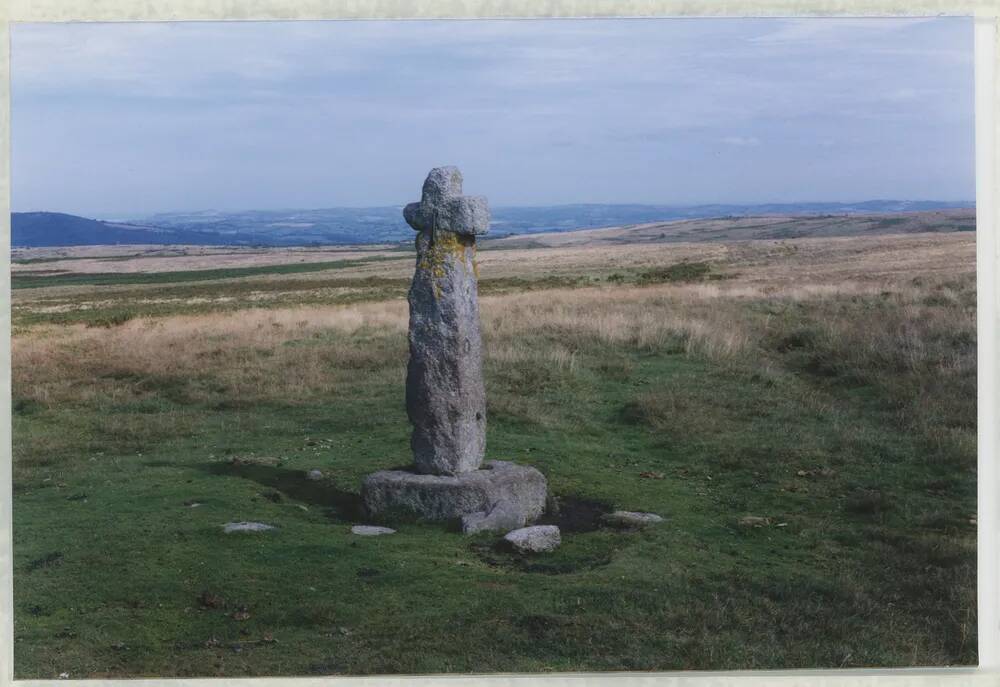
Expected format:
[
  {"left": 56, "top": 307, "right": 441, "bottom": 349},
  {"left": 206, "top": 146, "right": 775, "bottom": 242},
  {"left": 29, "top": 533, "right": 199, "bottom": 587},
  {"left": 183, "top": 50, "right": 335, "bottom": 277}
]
[{"left": 7, "top": 233, "right": 976, "bottom": 679}]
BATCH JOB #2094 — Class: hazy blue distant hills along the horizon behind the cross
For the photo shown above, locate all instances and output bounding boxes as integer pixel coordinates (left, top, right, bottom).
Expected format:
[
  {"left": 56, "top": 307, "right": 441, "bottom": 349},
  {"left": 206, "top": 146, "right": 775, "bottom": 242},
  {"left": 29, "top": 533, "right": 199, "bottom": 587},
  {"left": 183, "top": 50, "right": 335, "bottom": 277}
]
[{"left": 11, "top": 200, "right": 974, "bottom": 248}]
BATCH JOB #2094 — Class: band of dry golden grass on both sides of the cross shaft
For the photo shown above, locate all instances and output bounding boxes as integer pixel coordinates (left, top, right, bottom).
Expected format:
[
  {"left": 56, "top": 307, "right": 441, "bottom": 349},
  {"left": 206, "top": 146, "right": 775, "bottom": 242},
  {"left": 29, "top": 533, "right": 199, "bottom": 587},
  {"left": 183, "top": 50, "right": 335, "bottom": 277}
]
[{"left": 13, "top": 244, "right": 975, "bottom": 430}]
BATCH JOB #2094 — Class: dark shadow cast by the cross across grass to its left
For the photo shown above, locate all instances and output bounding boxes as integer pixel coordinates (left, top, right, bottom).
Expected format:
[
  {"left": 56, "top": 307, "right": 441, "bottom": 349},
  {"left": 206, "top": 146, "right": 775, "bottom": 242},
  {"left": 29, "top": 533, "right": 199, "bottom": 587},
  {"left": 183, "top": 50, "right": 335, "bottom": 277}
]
[{"left": 192, "top": 462, "right": 363, "bottom": 522}]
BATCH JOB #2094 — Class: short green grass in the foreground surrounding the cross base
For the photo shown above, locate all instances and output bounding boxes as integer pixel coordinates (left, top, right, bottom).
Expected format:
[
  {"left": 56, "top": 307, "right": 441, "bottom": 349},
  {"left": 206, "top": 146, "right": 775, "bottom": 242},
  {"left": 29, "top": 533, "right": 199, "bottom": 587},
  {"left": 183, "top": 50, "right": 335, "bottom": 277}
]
[{"left": 14, "top": 264, "right": 976, "bottom": 679}]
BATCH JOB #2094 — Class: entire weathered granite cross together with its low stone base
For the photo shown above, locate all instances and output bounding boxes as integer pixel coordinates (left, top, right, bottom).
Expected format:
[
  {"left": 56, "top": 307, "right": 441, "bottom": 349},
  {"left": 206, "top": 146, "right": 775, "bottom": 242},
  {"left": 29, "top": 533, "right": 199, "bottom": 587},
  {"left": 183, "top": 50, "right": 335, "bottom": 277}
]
[{"left": 361, "top": 167, "right": 548, "bottom": 534}]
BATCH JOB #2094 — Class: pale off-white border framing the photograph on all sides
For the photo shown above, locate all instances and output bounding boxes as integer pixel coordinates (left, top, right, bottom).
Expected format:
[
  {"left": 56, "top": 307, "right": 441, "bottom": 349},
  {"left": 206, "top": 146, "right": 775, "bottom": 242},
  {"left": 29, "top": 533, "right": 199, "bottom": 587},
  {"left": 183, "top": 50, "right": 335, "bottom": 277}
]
[{"left": 0, "top": 0, "right": 1000, "bottom": 687}]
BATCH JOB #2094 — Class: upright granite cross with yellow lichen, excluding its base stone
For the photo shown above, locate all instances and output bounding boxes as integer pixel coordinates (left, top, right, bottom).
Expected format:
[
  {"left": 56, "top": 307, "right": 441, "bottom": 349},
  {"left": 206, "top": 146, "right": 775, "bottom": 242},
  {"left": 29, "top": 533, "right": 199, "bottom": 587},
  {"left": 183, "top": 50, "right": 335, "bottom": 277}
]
[{"left": 403, "top": 167, "right": 490, "bottom": 475}]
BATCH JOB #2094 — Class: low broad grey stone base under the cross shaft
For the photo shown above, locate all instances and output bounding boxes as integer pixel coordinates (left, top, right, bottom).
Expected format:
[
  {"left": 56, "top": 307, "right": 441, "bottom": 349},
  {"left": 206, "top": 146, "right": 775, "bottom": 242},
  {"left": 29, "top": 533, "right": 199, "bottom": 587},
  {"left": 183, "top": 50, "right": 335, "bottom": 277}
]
[{"left": 361, "top": 460, "right": 547, "bottom": 522}]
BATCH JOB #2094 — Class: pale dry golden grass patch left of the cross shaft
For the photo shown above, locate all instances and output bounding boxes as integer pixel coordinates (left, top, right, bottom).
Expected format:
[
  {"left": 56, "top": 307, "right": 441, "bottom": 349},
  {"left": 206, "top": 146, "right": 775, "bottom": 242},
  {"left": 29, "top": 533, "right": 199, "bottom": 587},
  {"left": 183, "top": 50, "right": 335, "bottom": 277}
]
[{"left": 13, "top": 303, "right": 405, "bottom": 404}]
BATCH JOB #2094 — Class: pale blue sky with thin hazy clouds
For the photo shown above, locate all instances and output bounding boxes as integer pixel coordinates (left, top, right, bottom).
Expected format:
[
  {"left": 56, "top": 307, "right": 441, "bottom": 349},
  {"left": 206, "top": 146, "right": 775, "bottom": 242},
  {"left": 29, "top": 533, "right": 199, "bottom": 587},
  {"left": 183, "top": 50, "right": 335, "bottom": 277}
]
[{"left": 11, "top": 18, "right": 975, "bottom": 219}]
